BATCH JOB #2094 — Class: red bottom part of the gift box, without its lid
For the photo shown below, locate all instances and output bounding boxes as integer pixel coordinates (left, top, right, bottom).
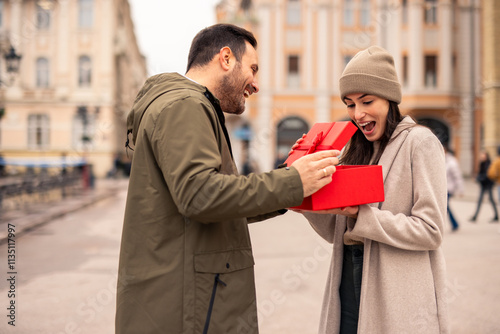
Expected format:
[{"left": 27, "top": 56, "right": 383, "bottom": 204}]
[{"left": 294, "top": 165, "right": 384, "bottom": 211}]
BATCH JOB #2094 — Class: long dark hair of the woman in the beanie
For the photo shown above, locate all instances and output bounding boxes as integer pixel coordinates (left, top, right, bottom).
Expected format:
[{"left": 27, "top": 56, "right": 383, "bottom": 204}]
[{"left": 340, "top": 101, "right": 413, "bottom": 165}]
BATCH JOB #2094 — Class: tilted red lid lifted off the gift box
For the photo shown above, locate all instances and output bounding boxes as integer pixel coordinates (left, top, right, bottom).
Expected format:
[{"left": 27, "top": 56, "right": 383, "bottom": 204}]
[{"left": 285, "top": 121, "right": 358, "bottom": 166}]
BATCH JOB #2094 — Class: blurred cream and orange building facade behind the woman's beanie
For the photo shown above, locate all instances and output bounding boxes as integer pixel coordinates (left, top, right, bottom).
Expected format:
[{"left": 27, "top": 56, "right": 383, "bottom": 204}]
[{"left": 217, "top": 0, "right": 484, "bottom": 175}]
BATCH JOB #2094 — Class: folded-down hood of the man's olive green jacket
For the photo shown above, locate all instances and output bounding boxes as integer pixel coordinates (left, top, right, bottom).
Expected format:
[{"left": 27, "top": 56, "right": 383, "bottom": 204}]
[{"left": 126, "top": 73, "right": 207, "bottom": 146}]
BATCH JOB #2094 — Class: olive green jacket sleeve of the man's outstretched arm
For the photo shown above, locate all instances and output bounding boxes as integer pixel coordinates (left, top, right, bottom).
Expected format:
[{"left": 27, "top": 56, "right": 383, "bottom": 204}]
[{"left": 151, "top": 97, "right": 303, "bottom": 223}]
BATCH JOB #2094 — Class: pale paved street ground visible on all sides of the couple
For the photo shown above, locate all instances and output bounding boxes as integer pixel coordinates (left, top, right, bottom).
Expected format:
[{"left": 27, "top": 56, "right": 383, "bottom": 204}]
[{"left": 0, "top": 177, "right": 500, "bottom": 334}]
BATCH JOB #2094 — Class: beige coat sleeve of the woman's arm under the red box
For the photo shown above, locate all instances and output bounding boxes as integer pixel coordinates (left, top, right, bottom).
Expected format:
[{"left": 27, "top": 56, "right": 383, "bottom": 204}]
[{"left": 352, "top": 137, "right": 447, "bottom": 250}]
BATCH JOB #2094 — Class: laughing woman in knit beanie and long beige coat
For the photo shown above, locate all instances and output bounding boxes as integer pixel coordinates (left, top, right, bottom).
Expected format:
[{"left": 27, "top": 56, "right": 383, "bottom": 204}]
[{"left": 296, "top": 46, "right": 448, "bottom": 334}]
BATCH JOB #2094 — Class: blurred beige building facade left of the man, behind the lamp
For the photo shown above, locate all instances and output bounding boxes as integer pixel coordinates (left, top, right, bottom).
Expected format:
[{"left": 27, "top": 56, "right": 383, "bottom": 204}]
[{"left": 0, "top": 0, "right": 147, "bottom": 177}]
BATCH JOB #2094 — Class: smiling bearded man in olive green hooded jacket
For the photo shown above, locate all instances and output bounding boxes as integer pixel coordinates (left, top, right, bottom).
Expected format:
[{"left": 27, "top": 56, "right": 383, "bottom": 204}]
[{"left": 116, "top": 24, "right": 339, "bottom": 334}]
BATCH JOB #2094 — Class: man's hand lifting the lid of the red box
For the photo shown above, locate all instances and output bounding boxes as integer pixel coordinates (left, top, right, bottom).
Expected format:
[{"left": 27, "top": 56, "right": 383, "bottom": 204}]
[{"left": 292, "top": 150, "right": 340, "bottom": 197}]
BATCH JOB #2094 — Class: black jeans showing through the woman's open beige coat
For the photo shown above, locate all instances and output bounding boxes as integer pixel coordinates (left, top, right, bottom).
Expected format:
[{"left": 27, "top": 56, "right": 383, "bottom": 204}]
[{"left": 339, "top": 245, "right": 364, "bottom": 334}]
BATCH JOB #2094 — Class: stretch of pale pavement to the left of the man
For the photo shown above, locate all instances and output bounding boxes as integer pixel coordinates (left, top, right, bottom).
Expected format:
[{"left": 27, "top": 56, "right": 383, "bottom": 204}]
[{"left": 0, "top": 183, "right": 125, "bottom": 334}]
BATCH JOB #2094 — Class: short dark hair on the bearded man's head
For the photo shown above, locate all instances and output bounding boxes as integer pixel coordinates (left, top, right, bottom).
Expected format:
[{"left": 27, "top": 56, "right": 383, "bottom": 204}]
[{"left": 186, "top": 24, "right": 257, "bottom": 72}]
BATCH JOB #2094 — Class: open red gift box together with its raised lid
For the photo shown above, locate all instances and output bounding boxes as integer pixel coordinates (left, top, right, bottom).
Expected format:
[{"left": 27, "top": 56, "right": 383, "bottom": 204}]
[{"left": 285, "top": 122, "right": 384, "bottom": 210}]
